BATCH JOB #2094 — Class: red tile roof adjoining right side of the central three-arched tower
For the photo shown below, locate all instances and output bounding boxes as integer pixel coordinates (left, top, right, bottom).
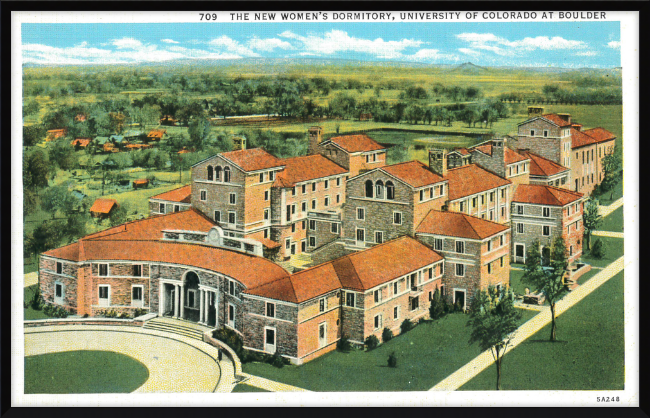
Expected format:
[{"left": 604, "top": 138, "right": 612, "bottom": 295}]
[{"left": 445, "top": 164, "right": 512, "bottom": 200}]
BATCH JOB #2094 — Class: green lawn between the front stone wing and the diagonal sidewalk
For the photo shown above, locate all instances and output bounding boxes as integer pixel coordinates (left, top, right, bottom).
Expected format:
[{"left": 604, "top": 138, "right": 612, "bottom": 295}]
[{"left": 242, "top": 310, "right": 536, "bottom": 392}]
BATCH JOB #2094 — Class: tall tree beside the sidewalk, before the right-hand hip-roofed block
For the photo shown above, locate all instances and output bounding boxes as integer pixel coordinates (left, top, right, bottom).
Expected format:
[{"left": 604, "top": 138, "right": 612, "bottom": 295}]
[{"left": 523, "top": 237, "right": 569, "bottom": 341}]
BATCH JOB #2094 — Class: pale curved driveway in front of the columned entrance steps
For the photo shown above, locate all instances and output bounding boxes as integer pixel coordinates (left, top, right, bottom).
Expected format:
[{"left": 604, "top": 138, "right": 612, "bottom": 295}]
[{"left": 25, "top": 325, "right": 234, "bottom": 393}]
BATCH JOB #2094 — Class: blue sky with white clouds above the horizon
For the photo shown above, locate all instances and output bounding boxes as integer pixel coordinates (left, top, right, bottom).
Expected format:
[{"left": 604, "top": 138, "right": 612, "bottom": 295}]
[{"left": 22, "top": 22, "right": 621, "bottom": 68}]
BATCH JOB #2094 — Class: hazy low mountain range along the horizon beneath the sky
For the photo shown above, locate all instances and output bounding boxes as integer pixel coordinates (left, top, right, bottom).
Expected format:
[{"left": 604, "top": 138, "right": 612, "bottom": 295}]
[{"left": 23, "top": 58, "right": 621, "bottom": 74}]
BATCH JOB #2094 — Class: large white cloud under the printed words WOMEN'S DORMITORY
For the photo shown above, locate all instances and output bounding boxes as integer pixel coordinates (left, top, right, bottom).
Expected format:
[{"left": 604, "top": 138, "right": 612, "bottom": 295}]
[{"left": 279, "top": 29, "right": 424, "bottom": 58}]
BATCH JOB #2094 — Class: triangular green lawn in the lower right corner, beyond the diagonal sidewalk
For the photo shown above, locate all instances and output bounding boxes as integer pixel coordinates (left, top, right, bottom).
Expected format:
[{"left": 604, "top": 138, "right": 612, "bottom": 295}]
[{"left": 460, "top": 271, "right": 625, "bottom": 390}]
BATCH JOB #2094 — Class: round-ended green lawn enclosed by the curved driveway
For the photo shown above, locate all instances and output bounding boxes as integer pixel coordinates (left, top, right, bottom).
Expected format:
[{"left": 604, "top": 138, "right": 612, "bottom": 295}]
[{"left": 25, "top": 351, "right": 149, "bottom": 393}]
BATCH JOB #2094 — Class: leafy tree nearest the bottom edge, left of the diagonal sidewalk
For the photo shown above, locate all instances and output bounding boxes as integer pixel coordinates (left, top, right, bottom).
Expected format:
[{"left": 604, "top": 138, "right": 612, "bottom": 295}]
[{"left": 467, "top": 286, "right": 521, "bottom": 390}]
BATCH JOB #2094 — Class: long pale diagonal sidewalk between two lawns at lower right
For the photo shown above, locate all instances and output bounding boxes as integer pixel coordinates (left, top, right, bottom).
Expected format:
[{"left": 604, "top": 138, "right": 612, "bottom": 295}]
[{"left": 429, "top": 257, "right": 624, "bottom": 391}]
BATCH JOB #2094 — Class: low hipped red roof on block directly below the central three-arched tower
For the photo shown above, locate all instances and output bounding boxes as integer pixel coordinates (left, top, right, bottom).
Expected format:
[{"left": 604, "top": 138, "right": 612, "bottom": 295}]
[{"left": 416, "top": 210, "right": 510, "bottom": 240}]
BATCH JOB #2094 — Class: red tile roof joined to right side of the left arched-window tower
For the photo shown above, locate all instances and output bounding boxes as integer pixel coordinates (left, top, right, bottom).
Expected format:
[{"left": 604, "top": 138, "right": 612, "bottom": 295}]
[{"left": 274, "top": 154, "right": 348, "bottom": 187}]
